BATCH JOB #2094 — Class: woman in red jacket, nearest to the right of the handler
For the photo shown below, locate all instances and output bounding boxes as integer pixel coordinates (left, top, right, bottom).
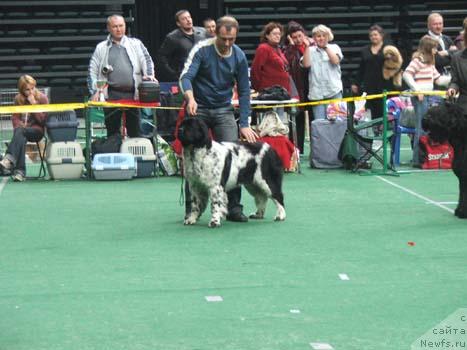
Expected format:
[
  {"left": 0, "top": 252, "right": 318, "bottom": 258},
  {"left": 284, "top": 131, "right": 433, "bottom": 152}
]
[{"left": 250, "top": 22, "right": 292, "bottom": 96}]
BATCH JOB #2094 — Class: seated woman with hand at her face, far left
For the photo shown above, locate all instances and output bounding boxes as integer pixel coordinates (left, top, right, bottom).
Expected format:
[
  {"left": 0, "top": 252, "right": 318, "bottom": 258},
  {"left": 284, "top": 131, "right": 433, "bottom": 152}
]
[{"left": 0, "top": 75, "right": 49, "bottom": 181}]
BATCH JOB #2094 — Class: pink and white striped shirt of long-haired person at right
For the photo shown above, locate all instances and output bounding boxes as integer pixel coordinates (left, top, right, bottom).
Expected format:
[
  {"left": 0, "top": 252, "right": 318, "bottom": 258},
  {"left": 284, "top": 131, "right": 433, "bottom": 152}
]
[{"left": 404, "top": 58, "right": 440, "bottom": 91}]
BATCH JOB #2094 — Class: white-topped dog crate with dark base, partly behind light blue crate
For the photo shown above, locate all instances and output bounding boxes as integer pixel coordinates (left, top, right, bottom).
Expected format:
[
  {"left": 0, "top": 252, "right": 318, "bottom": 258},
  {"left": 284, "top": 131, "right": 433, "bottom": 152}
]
[{"left": 120, "top": 137, "right": 156, "bottom": 177}]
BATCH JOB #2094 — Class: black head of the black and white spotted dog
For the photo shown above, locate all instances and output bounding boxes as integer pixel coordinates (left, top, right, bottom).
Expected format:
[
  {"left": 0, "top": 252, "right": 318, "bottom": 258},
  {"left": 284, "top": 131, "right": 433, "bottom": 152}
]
[{"left": 178, "top": 117, "right": 212, "bottom": 148}]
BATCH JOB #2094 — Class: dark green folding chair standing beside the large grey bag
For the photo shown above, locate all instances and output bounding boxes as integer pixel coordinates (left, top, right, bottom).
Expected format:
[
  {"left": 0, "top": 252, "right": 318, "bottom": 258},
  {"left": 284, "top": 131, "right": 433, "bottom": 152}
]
[{"left": 340, "top": 103, "right": 396, "bottom": 171}]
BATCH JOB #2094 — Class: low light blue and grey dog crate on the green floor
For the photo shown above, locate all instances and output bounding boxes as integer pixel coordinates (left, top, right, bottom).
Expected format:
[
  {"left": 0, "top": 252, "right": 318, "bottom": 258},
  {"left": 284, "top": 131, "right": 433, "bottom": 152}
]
[{"left": 92, "top": 153, "right": 136, "bottom": 180}]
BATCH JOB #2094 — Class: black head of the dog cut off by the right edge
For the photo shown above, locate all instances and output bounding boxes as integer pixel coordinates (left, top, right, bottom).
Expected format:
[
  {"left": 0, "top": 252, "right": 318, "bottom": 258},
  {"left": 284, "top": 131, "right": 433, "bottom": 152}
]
[{"left": 422, "top": 102, "right": 467, "bottom": 142}]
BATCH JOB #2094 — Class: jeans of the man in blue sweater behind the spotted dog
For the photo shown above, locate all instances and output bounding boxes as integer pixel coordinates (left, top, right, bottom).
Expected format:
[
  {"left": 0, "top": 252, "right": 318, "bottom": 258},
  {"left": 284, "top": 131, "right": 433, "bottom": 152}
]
[{"left": 185, "top": 107, "right": 243, "bottom": 215}]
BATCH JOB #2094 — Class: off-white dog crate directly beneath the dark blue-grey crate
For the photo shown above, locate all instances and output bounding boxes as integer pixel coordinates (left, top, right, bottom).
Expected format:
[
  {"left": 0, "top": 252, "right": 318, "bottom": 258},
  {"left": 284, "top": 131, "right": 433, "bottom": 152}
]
[{"left": 46, "top": 141, "right": 84, "bottom": 180}]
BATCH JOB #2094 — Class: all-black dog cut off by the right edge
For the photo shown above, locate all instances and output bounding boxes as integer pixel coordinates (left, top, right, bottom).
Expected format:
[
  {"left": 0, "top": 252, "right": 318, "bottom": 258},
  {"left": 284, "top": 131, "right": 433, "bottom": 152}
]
[{"left": 422, "top": 102, "right": 467, "bottom": 219}]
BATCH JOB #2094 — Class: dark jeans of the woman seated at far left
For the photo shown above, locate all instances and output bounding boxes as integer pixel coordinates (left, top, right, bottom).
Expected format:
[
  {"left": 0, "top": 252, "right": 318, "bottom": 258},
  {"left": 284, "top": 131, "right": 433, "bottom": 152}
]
[{"left": 5, "top": 128, "right": 44, "bottom": 175}]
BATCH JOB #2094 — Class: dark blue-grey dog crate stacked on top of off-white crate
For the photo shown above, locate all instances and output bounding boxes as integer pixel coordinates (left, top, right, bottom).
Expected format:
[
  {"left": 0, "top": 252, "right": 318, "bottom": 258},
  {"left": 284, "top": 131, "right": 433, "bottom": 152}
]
[{"left": 46, "top": 110, "right": 79, "bottom": 142}]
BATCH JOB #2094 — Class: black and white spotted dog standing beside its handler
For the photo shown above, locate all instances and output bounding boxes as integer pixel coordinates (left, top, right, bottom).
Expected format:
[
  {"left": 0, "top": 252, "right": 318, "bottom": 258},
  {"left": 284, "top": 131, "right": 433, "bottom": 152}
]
[{"left": 178, "top": 117, "right": 286, "bottom": 227}]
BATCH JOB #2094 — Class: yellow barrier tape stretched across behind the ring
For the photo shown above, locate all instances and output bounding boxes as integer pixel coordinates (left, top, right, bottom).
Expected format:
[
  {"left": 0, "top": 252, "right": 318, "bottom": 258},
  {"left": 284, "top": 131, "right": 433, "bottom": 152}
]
[{"left": 0, "top": 91, "right": 446, "bottom": 114}]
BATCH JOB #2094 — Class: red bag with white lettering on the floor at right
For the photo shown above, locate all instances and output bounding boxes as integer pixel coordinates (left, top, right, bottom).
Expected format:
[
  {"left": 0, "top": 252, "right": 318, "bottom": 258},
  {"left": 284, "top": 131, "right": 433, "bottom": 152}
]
[{"left": 420, "top": 135, "right": 454, "bottom": 169}]
